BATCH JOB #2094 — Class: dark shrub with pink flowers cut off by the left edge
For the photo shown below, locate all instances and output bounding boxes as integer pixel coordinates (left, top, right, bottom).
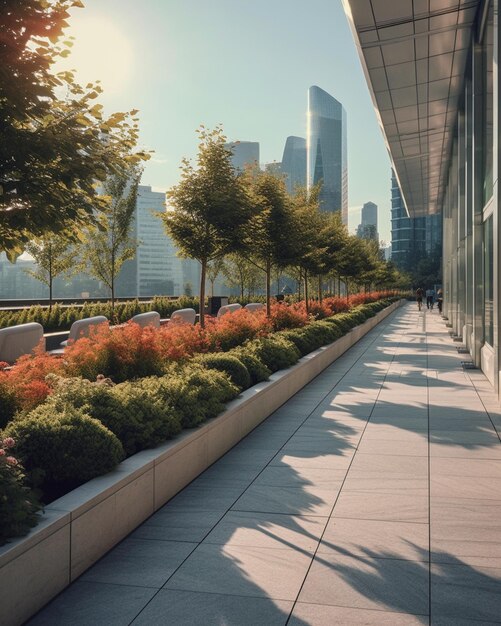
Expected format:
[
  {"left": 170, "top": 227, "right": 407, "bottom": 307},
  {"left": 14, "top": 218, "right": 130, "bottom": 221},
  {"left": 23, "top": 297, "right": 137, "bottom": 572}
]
[{"left": 0, "top": 437, "right": 40, "bottom": 546}]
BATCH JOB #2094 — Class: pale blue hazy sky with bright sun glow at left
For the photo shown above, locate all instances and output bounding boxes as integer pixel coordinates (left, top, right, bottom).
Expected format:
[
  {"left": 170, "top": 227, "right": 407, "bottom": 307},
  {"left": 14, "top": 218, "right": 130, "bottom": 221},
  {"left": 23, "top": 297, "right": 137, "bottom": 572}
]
[{"left": 56, "top": 0, "right": 391, "bottom": 243}]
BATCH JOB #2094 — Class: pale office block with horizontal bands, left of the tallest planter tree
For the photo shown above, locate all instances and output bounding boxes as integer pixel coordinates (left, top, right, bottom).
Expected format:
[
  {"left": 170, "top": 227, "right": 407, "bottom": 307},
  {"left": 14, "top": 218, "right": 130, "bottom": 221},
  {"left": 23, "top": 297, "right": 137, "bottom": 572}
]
[{"left": 134, "top": 185, "right": 183, "bottom": 296}]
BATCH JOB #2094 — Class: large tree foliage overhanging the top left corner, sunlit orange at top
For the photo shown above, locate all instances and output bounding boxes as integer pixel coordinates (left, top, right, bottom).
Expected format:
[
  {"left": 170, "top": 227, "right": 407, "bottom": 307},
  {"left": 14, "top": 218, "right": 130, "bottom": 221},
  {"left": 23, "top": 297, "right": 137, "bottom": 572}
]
[{"left": 0, "top": 0, "right": 148, "bottom": 259}]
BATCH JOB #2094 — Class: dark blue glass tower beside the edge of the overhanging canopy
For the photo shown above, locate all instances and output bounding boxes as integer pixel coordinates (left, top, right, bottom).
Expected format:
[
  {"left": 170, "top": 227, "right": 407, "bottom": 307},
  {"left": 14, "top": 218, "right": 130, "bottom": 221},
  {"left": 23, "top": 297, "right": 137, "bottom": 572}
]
[{"left": 391, "top": 171, "right": 426, "bottom": 270}]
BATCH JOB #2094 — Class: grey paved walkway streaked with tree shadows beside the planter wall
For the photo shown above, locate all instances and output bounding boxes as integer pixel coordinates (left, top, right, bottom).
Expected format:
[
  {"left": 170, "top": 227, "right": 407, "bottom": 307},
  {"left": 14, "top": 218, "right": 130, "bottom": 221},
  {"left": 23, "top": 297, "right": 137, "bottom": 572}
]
[{"left": 30, "top": 304, "right": 501, "bottom": 626}]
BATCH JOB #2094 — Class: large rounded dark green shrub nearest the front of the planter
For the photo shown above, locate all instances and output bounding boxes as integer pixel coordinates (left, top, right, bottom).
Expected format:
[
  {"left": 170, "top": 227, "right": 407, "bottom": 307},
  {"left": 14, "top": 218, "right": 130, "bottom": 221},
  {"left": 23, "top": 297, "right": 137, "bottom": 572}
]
[{"left": 5, "top": 404, "right": 124, "bottom": 502}]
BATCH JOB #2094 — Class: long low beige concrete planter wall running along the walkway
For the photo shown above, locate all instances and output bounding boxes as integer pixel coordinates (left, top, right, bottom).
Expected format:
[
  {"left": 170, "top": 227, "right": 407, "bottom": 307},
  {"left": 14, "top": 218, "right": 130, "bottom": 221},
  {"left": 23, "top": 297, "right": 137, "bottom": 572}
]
[{"left": 0, "top": 301, "right": 402, "bottom": 626}]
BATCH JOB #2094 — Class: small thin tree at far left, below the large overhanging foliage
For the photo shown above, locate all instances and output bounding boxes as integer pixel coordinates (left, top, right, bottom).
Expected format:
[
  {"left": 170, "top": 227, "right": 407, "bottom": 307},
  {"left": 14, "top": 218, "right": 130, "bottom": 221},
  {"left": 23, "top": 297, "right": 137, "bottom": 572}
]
[{"left": 25, "top": 235, "right": 75, "bottom": 310}]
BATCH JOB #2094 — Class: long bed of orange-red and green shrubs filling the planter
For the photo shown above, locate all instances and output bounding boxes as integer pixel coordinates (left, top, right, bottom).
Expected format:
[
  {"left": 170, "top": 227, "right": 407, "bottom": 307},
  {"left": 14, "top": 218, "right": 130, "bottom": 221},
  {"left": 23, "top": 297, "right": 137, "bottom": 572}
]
[{"left": 0, "top": 292, "right": 398, "bottom": 541}]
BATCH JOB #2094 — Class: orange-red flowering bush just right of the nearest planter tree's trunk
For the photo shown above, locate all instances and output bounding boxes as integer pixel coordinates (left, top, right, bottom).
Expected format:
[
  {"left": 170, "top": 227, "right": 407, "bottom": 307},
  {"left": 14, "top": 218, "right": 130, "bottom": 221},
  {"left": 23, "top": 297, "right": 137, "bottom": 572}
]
[{"left": 207, "top": 309, "right": 272, "bottom": 351}]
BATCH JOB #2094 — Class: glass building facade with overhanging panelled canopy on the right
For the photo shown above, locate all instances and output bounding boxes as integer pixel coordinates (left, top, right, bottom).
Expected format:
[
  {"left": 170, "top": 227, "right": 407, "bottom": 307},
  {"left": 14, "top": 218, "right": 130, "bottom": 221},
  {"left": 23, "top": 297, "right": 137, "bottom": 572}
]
[{"left": 343, "top": 0, "right": 501, "bottom": 393}]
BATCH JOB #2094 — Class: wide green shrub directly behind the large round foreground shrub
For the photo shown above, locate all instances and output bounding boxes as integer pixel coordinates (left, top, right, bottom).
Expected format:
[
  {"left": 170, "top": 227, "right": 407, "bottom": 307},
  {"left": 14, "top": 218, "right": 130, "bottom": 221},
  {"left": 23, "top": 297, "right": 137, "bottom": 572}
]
[{"left": 48, "top": 378, "right": 181, "bottom": 456}]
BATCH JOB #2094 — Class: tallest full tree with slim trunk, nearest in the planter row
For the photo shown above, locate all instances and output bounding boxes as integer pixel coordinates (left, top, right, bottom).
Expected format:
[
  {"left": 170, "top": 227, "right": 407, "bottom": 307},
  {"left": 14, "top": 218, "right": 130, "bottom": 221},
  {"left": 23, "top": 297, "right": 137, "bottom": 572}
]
[{"left": 161, "top": 126, "right": 249, "bottom": 327}]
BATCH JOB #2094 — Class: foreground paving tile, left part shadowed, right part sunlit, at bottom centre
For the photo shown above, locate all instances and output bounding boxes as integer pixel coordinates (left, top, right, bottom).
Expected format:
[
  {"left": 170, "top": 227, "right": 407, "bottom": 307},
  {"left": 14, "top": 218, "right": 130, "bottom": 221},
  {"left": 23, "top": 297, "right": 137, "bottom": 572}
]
[{"left": 165, "top": 544, "right": 311, "bottom": 600}]
